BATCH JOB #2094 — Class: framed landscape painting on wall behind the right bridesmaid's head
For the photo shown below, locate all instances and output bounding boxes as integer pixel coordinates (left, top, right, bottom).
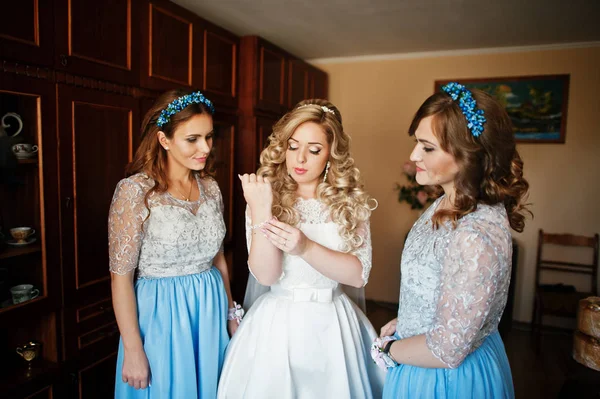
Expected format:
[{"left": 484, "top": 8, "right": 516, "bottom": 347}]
[{"left": 435, "top": 75, "right": 570, "bottom": 143}]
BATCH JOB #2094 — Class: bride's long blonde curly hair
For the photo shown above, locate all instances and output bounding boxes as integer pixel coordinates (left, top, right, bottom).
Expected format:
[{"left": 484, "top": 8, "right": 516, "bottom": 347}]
[{"left": 257, "top": 99, "right": 376, "bottom": 252}]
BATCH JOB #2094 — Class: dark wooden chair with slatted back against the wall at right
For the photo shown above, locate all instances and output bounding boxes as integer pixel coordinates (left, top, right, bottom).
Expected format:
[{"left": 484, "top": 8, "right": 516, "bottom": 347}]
[{"left": 532, "top": 229, "right": 598, "bottom": 353}]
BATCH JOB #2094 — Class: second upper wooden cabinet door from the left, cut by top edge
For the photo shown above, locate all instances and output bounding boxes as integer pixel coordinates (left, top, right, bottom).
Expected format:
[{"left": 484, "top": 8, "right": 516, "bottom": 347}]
[{"left": 54, "top": 0, "right": 139, "bottom": 85}]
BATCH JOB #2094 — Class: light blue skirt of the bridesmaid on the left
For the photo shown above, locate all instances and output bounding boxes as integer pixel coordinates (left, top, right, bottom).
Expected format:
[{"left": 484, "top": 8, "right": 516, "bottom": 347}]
[{"left": 115, "top": 267, "right": 229, "bottom": 399}]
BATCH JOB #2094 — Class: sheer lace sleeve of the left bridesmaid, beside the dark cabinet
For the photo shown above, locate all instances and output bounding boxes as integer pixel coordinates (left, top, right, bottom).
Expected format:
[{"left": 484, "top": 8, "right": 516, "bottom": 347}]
[{"left": 108, "top": 179, "right": 148, "bottom": 275}]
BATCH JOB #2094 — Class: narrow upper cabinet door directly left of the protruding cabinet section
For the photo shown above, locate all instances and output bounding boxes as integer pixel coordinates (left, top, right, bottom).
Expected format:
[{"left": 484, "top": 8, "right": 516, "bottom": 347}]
[{"left": 202, "top": 24, "right": 240, "bottom": 109}]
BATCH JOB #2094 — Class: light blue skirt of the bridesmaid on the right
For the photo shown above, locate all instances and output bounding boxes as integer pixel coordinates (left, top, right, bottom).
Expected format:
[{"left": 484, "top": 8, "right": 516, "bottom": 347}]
[{"left": 383, "top": 331, "right": 515, "bottom": 399}]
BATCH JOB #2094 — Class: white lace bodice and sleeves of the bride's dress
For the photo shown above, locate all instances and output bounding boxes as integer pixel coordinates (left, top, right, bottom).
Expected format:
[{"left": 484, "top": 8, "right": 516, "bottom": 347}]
[{"left": 246, "top": 198, "right": 372, "bottom": 289}]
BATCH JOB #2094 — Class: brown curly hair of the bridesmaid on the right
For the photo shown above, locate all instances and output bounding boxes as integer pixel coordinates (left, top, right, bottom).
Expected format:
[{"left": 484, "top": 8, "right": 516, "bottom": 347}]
[{"left": 408, "top": 89, "right": 532, "bottom": 232}]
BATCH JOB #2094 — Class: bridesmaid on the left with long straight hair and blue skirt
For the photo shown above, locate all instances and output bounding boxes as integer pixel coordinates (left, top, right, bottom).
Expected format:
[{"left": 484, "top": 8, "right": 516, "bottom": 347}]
[{"left": 108, "top": 90, "right": 237, "bottom": 399}]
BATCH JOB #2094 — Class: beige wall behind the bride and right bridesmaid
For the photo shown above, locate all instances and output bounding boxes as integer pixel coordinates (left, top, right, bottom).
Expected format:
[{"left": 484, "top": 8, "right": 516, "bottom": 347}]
[{"left": 319, "top": 47, "right": 600, "bottom": 321}]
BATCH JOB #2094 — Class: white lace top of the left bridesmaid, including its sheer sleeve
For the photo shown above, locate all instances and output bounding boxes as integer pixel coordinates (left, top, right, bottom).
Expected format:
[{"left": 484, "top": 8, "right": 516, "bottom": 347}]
[{"left": 108, "top": 173, "right": 225, "bottom": 278}]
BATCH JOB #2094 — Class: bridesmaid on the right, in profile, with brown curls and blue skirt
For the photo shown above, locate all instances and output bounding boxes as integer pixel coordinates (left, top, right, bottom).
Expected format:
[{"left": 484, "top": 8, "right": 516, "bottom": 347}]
[{"left": 372, "top": 83, "right": 529, "bottom": 399}]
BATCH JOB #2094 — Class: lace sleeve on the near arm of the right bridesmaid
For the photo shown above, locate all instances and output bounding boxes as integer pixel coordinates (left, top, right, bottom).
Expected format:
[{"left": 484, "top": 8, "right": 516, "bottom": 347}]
[{"left": 426, "top": 229, "right": 509, "bottom": 368}]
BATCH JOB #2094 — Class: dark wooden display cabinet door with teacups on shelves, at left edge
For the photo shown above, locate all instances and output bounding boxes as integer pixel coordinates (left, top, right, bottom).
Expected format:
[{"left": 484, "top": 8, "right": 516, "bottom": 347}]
[{"left": 0, "top": 71, "right": 61, "bottom": 310}]
